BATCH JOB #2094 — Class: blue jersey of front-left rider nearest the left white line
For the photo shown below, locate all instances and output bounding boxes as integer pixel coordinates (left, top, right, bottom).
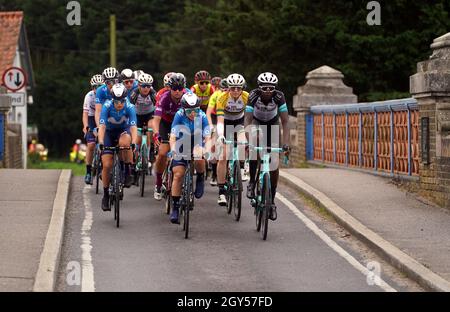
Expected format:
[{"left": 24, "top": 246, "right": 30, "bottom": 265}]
[{"left": 100, "top": 99, "right": 137, "bottom": 130}]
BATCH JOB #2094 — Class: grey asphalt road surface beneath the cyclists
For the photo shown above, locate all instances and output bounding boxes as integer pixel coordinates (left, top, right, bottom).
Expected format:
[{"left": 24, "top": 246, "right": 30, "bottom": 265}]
[{"left": 57, "top": 172, "right": 417, "bottom": 292}]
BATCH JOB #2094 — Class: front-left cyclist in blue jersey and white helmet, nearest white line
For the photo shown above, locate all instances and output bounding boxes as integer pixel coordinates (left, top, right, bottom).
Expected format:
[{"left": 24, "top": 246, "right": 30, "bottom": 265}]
[{"left": 98, "top": 84, "right": 137, "bottom": 211}]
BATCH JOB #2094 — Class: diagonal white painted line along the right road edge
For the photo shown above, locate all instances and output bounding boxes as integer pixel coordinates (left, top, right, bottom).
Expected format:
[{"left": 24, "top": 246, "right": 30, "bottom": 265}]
[{"left": 277, "top": 193, "right": 397, "bottom": 292}]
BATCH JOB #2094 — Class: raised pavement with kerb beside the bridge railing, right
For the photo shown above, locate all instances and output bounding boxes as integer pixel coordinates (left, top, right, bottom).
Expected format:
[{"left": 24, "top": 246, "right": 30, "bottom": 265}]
[{"left": 280, "top": 168, "right": 450, "bottom": 291}]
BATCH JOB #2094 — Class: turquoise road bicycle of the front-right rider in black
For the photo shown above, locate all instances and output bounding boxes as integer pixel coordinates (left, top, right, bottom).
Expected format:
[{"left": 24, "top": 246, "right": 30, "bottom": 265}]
[{"left": 250, "top": 145, "right": 288, "bottom": 240}]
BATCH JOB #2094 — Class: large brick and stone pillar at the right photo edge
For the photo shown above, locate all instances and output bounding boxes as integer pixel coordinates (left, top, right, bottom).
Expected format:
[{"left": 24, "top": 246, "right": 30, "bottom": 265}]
[{"left": 410, "top": 33, "right": 450, "bottom": 209}]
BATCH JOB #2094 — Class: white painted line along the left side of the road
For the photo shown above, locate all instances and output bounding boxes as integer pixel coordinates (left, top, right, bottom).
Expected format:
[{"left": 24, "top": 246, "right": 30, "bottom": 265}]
[{"left": 81, "top": 185, "right": 95, "bottom": 292}]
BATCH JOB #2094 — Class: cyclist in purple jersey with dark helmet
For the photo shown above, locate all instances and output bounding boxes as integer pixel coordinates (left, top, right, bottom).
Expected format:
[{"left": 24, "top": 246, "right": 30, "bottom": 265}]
[{"left": 153, "top": 73, "right": 186, "bottom": 200}]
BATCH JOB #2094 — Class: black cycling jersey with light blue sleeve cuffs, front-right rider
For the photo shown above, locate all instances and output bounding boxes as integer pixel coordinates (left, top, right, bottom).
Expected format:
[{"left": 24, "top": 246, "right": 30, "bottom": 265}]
[{"left": 245, "top": 89, "right": 288, "bottom": 124}]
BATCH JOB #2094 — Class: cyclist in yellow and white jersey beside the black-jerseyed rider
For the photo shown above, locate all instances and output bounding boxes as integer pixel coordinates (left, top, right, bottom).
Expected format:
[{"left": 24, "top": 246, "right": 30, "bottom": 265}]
[{"left": 216, "top": 74, "right": 248, "bottom": 206}]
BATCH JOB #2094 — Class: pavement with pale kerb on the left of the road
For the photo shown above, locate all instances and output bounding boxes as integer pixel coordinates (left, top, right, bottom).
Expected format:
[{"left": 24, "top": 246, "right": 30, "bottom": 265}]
[{"left": 0, "top": 169, "right": 70, "bottom": 292}]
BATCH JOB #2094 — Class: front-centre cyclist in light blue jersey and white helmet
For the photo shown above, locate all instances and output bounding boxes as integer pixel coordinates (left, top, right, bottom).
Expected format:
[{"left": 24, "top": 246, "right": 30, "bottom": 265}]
[{"left": 169, "top": 93, "right": 211, "bottom": 223}]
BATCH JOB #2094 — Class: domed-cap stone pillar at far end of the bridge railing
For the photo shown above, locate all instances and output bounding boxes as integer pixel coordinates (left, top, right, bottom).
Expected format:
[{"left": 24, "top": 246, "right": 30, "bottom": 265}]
[{"left": 293, "top": 66, "right": 358, "bottom": 163}]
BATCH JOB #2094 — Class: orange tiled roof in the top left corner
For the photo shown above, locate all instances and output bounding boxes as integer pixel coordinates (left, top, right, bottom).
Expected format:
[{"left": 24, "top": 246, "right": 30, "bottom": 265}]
[{"left": 0, "top": 11, "right": 23, "bottom": 79}]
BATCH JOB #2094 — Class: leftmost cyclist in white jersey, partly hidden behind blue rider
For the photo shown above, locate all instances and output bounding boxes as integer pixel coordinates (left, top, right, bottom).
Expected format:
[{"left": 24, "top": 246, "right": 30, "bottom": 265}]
[{"left": 83, "top": 75, "right": 103, "bottom": 184}]
